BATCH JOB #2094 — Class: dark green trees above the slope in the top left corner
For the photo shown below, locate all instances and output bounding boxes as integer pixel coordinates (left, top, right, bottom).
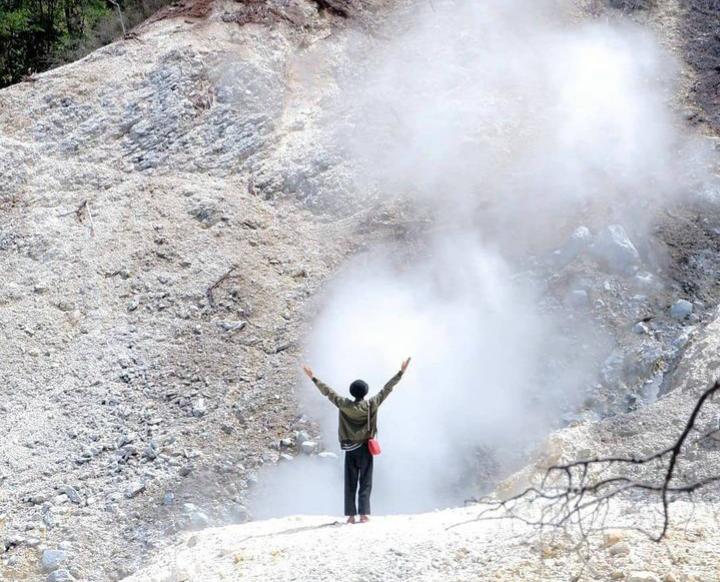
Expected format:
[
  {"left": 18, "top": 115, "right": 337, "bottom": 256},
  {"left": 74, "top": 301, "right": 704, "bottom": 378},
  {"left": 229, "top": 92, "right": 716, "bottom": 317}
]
[{"left": 0, "top": 0, "right": 169, "bottom": 88}]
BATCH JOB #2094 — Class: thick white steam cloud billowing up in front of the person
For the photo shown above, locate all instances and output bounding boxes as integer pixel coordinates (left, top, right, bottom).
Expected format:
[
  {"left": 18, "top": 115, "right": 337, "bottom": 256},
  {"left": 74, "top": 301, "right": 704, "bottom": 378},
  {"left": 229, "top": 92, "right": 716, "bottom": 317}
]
[{"left": 250, "top": 0, "right": 702, "bottom": 516}]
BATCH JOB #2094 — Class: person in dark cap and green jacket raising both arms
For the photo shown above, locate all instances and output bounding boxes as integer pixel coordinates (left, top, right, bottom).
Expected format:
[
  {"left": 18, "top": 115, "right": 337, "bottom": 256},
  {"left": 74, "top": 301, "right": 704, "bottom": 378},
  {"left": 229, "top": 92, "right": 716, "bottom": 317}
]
[{"left": 303, "top": 358, "right": 410, "bottom": 523}]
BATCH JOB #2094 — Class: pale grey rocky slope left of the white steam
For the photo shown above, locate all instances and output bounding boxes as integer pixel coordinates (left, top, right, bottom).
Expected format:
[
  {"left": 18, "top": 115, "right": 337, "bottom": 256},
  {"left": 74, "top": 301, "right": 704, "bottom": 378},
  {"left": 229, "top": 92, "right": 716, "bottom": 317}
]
[{"left": 0, "top": 2, "right": 372, "bottom": 580}]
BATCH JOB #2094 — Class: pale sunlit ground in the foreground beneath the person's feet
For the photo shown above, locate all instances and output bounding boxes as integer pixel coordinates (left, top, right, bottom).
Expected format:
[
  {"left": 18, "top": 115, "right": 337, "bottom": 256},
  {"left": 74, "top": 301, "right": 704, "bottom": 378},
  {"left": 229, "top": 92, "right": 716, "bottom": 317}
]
[{"left": 128, "top": 504, "right": 720, "bottom": 582}]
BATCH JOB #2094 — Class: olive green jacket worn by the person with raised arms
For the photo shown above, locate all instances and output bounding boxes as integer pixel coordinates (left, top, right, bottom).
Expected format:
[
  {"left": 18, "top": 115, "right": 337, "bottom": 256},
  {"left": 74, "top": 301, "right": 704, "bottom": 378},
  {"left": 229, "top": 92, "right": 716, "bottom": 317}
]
[{"left": 313, "top": 371, "right": 403, "bottom": 443}]
